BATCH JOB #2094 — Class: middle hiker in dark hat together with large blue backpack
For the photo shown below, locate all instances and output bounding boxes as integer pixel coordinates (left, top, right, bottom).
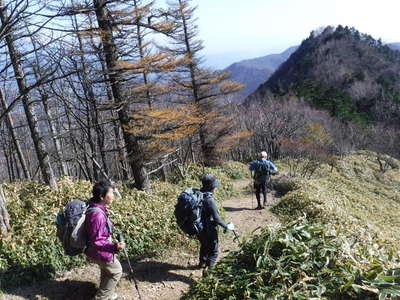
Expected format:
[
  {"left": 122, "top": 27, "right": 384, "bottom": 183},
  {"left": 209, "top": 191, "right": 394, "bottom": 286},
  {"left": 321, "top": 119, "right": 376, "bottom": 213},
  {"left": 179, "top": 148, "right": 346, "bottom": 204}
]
[{"left": 174, "top": 174, "right": 235, "bottom": 276}]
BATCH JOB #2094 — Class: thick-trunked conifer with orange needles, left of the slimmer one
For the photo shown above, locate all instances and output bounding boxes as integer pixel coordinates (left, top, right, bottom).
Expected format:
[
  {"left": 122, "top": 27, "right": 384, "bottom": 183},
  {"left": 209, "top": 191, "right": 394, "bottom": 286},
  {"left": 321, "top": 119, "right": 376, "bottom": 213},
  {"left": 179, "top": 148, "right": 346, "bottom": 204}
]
[{"left": 65, "top": 0, "right": 183, "bottom": 190}]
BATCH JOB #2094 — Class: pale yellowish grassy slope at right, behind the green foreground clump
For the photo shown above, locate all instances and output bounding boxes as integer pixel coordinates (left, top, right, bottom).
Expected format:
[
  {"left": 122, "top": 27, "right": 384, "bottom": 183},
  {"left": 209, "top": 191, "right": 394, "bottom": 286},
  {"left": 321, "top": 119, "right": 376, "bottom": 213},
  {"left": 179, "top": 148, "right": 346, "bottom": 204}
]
[{"left": 273, "top": 151, "right": 400, "bottom": 246}]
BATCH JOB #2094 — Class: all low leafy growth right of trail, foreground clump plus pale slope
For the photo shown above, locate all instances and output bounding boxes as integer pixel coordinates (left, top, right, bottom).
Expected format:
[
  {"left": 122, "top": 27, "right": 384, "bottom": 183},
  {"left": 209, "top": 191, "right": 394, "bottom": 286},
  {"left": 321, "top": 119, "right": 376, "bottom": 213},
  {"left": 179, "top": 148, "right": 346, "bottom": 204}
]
[{"left": 184, "top": 151, "right": 400, "bottom": 300}]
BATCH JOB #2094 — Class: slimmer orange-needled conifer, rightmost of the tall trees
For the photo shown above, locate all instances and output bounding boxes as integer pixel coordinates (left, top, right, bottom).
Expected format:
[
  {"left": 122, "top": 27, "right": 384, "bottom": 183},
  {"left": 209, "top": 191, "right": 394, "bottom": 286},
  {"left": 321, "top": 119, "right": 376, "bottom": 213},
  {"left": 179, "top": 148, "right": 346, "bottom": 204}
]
[{"left": 162, "top": 0, "right": 243, "bottom": 165}]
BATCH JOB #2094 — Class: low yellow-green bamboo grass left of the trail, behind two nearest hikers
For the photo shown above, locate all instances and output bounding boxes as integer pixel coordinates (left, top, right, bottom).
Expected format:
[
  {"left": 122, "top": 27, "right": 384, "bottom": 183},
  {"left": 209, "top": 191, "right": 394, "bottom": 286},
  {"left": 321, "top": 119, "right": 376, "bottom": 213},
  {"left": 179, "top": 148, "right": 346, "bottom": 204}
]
[{"left": 0, "top": 163, "right": 247, "bottom": 288}]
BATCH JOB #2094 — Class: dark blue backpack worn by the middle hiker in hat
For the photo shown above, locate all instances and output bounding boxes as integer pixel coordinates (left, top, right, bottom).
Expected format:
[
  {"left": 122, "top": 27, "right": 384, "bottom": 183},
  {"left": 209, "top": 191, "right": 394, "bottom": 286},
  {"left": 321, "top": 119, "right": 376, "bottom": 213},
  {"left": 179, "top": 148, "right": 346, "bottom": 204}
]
[{"left": 174, "top": 188, "right": 204, "bottom": 236}]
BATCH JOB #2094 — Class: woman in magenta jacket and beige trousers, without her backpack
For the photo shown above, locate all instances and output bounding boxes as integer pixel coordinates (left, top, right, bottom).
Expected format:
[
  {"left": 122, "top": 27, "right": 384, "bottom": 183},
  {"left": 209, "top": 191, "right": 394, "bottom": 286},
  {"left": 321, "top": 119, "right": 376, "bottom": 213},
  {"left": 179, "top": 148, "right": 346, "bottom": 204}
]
[{"left": 85, "top": 181, "right": 125, "bottom": 300}]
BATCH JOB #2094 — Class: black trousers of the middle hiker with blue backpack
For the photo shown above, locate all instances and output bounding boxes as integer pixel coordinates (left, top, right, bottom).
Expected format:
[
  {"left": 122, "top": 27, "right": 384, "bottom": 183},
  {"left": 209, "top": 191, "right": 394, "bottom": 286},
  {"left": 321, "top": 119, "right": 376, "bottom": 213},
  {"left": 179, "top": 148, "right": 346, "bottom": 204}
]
[{"left": 198, "top": 225, "right": 218, "bottom": 267}]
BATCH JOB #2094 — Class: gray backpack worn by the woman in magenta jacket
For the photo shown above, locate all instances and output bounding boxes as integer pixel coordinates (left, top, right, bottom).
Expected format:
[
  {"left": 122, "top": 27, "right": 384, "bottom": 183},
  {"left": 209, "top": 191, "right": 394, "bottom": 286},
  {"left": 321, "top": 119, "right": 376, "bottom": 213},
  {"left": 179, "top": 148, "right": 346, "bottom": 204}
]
[{"left": 56, "top": 200, "right": 102, "bottom": 256}]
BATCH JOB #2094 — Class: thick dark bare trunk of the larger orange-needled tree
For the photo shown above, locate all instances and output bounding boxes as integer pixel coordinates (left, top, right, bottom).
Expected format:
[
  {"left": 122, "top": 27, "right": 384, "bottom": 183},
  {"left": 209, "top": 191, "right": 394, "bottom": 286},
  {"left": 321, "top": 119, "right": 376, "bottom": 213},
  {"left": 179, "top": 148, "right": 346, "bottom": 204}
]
[{"left": 93, "top": 0, "right": 150, "bottom": 190}]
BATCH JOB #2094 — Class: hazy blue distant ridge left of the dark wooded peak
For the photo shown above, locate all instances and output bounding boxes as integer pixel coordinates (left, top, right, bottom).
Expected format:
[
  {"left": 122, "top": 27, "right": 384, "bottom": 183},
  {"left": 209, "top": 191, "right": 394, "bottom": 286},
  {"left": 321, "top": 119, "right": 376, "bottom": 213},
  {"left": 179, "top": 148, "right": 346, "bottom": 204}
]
[{"left": 224, "top": 46, "right": 298, "bottom": 97}]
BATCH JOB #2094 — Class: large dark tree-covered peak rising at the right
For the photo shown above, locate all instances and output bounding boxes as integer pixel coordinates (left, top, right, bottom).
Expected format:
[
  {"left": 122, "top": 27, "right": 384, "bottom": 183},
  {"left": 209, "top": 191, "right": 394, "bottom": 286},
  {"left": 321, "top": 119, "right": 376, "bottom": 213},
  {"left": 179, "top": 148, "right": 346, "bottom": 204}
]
[{"left": 248, "top": 25, "right": 400, "bottom": 123}]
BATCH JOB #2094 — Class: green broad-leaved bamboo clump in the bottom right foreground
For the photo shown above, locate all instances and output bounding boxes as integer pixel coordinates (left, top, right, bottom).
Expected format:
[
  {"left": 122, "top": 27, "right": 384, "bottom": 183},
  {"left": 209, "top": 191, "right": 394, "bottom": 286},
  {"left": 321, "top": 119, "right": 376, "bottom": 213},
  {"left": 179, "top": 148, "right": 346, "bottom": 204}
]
[{"left": 183, "top": 218, "right": 400, "bottom": 300}]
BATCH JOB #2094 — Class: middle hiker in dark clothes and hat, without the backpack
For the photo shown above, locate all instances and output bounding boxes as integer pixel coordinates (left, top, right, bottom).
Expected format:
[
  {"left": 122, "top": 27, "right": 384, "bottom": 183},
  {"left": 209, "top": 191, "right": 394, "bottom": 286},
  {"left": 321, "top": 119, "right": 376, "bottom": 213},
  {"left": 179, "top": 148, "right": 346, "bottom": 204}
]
[{"left": 198, "top": 174, "right": 235, "bottom": 276}]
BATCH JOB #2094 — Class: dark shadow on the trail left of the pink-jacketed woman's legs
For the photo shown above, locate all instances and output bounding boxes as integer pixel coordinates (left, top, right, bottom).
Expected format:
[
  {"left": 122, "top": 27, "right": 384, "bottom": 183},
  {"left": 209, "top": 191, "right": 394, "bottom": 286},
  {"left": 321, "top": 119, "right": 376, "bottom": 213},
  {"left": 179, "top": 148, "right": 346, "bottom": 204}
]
[{"left": 7, "top": 280, "right": 96, "bottom": 300}]
